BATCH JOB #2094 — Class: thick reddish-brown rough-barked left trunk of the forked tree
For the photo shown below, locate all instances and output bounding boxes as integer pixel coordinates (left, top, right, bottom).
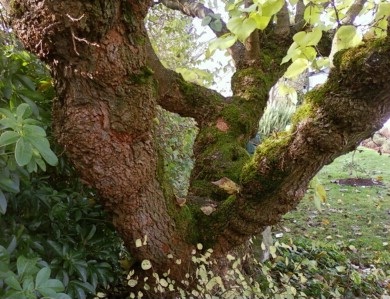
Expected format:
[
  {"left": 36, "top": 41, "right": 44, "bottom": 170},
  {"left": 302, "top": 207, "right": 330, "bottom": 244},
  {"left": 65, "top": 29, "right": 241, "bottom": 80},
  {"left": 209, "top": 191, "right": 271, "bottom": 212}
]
[{"left": 6, "top": 1, "right": 195, "bottom": 278}]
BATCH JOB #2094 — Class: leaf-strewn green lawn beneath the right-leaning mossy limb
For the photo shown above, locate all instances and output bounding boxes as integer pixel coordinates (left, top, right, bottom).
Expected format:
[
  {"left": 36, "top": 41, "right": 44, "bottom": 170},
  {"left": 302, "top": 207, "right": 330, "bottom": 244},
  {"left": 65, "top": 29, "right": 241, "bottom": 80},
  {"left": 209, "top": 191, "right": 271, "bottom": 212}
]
[{"left": 273, "top": 148, "right": 390, "bottom": 273}]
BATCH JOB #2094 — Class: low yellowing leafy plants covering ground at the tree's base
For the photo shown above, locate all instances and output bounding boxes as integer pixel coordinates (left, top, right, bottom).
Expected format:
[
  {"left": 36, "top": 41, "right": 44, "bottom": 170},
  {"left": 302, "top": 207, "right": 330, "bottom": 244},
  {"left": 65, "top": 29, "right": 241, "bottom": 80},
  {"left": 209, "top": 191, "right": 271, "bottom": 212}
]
[{"left": 123, "top": 241, "right": 390, "bottom": 299}]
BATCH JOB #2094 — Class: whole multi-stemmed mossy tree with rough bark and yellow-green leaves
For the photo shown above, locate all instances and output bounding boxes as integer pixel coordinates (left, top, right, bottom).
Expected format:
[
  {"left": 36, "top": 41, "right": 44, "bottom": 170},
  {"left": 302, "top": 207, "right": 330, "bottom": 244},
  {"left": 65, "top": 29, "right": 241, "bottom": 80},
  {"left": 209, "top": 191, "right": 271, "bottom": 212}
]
[{"left": 2, "top": 0, "right": 390, "bottom": 290}]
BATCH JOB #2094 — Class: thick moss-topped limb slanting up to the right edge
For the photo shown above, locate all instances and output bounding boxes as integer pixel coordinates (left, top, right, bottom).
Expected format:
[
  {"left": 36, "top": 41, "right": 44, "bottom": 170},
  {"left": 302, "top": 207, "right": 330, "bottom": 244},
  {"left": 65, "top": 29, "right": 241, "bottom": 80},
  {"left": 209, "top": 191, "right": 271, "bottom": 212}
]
[{"left": 204, "top": 40, "right": 390, "bottom": 251}]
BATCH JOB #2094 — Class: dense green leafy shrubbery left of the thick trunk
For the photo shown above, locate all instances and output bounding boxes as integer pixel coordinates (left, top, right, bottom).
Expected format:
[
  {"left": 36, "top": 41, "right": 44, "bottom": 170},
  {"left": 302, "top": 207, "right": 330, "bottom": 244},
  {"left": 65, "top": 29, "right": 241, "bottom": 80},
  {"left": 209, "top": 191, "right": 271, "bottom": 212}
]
[{"left": 0, "top": 37, "right": 124, "bottom": 299}]
